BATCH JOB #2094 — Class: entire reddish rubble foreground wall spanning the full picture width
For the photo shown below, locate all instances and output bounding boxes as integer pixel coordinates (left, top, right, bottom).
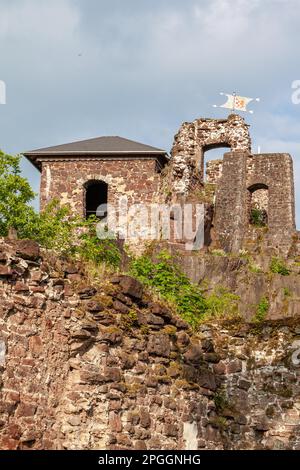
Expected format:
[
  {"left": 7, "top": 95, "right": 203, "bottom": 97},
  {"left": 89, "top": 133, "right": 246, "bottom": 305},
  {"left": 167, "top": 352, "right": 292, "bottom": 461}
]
[{"left": 0, "top": 241, "right": 300, "bottom": 450}]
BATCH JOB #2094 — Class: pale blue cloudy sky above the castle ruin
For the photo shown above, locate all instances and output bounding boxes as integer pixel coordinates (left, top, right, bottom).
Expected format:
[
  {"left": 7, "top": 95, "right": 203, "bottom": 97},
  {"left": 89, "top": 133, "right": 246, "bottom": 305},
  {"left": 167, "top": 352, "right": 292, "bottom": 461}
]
[{"left": 0, "top": 0, "right": 300, "bottom": 227}]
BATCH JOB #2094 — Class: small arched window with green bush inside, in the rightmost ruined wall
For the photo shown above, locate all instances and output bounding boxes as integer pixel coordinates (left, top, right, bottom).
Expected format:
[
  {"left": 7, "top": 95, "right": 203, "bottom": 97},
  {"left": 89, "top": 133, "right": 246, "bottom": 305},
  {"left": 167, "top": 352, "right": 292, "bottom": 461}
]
[{"left": 248, "top": 183, "right": 269, "bottom": 227}]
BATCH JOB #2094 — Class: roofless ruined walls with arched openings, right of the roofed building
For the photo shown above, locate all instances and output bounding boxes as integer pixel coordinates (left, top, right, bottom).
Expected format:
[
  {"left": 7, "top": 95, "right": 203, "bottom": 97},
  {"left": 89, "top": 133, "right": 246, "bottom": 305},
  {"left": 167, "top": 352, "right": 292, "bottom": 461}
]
[{"left": 170, "top": 114, "right": 296, "bottom": 252}]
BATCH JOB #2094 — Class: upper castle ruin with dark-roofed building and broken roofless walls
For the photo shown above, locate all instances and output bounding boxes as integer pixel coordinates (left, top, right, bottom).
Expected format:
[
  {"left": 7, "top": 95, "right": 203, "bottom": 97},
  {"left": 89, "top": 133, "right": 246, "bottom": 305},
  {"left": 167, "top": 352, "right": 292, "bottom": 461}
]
[{"left": 24, "top": 114, "right": 296, "bottom": 254}]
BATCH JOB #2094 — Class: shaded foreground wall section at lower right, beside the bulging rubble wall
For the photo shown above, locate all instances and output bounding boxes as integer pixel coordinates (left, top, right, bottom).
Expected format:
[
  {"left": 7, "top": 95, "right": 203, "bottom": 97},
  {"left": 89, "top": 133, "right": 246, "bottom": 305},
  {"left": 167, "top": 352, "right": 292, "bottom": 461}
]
[{"left": 202, "top": 319, "right": 300, "bottom": 450}]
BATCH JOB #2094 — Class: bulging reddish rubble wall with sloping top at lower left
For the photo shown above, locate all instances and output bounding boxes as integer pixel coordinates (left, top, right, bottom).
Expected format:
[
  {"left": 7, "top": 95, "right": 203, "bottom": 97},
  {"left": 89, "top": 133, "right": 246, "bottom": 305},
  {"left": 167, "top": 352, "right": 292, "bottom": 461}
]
[{"left": 0, "top": 241, "right": 222, "bottom": 449}]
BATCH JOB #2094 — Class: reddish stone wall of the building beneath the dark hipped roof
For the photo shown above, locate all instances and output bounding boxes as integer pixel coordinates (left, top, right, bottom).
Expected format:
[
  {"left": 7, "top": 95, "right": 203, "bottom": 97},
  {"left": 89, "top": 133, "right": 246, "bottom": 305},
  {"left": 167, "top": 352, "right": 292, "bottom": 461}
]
[{"left": 40, "top": 157, "right": 160, "bottom": 215}]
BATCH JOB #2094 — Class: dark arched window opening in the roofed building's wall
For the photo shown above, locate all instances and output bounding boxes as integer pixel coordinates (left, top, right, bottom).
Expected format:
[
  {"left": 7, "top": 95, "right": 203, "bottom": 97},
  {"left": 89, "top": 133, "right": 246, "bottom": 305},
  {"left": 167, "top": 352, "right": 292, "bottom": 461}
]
[{"left": 85, "top": 180, "right": 108, "bottom": 219}]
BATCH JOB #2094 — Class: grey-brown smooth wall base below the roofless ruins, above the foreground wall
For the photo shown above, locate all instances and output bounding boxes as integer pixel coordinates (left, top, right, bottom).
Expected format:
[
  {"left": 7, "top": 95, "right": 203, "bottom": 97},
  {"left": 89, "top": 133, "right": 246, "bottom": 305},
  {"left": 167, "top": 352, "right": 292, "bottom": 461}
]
[{"left": 166, "top": 245, "right": 300, "bottom": 322}]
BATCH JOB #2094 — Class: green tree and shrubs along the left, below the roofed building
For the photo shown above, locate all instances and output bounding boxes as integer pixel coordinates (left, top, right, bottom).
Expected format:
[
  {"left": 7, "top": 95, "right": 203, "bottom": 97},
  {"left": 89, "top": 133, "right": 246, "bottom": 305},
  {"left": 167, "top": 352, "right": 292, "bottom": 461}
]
[{"left": 0, "top": 151, "right": 121, "bottom": 267}]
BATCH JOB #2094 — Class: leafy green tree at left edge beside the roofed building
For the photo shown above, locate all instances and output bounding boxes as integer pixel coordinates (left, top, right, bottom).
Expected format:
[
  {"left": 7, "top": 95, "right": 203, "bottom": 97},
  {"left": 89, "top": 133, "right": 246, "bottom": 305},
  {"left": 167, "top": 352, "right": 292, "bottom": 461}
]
[{"left": 0, "top": 150, "right": 35, "bottom": 237}]
